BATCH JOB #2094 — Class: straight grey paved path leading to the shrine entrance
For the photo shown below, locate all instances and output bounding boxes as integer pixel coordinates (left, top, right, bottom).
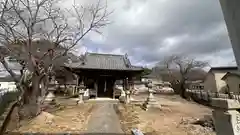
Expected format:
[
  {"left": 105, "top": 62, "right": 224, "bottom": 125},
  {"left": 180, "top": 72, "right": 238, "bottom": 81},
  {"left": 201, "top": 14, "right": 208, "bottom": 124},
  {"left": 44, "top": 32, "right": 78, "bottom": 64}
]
[{"left": 87, "top": 101, "right": 124, "bottom": 135}]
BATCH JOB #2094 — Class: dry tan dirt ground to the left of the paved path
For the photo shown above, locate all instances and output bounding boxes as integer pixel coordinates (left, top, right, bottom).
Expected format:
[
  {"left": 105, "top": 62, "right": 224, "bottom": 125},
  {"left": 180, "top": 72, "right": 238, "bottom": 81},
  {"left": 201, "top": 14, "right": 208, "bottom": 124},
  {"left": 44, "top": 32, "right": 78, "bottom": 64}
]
[{"left": 7, "top": 100, "right": 94, "bottom": 134}]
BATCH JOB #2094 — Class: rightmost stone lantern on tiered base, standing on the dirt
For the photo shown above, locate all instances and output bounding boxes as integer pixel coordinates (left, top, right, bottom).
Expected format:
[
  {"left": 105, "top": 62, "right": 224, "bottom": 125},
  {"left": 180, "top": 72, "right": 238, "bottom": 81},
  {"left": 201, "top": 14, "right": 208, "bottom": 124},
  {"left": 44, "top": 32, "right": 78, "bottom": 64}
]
[{"left": 143, "top": 89, "right": 161, "bottom": 110}]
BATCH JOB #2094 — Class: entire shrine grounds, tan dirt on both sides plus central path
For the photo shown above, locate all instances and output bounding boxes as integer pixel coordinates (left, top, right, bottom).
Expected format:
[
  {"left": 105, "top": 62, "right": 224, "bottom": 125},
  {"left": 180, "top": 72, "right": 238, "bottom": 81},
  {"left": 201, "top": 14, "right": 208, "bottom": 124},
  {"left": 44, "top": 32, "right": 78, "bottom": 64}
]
[{"left": 6, "top": 94, "right": 215, "bottom": 135}]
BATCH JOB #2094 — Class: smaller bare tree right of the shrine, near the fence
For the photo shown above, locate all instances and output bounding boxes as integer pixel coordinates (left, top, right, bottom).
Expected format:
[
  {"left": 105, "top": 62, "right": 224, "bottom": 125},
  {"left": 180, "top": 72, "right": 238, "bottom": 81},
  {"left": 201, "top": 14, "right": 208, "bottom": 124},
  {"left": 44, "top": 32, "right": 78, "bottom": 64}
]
[{"left": 158, "top": 55, "right": 208, "bottom": 98}]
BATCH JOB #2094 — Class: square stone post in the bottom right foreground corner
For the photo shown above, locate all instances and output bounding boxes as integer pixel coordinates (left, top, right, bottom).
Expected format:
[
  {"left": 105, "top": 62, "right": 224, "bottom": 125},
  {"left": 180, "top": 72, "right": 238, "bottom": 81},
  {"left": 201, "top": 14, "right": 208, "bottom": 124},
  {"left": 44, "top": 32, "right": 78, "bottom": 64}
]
[{"left": 211, "top": 98, "right": 240, "bottom": 135}]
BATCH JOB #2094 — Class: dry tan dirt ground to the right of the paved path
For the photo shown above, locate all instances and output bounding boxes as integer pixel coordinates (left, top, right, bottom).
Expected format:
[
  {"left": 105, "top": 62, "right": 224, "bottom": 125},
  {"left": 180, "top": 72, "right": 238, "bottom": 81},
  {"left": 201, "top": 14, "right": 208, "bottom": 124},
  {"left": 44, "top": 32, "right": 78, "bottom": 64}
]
[{"left": 117, "top": 95, "right": 215, "bottom": 135}]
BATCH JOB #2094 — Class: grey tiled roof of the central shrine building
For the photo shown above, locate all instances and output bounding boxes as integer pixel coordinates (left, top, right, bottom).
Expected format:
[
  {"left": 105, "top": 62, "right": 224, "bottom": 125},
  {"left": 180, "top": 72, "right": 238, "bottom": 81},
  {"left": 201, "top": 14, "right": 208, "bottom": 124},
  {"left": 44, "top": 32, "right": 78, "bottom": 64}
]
[{"left": 65, "top": 53, "right": 143, "bottom": 71}]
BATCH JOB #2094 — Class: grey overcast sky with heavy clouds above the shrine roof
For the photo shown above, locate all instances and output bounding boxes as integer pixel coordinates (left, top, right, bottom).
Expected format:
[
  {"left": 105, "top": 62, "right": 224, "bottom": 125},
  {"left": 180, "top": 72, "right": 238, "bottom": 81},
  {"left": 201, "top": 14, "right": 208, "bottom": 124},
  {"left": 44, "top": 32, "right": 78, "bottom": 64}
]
[{"left": 69, "top": 0, "right": 235, "bottom": 66}]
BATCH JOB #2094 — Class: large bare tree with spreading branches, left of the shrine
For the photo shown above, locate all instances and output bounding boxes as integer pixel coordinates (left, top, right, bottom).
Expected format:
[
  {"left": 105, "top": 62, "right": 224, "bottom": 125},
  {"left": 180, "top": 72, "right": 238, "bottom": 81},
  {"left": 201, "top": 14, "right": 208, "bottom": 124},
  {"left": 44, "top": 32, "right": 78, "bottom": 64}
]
[{"left": 0, "top": 0, "right": 109, "bottom": 132}]
